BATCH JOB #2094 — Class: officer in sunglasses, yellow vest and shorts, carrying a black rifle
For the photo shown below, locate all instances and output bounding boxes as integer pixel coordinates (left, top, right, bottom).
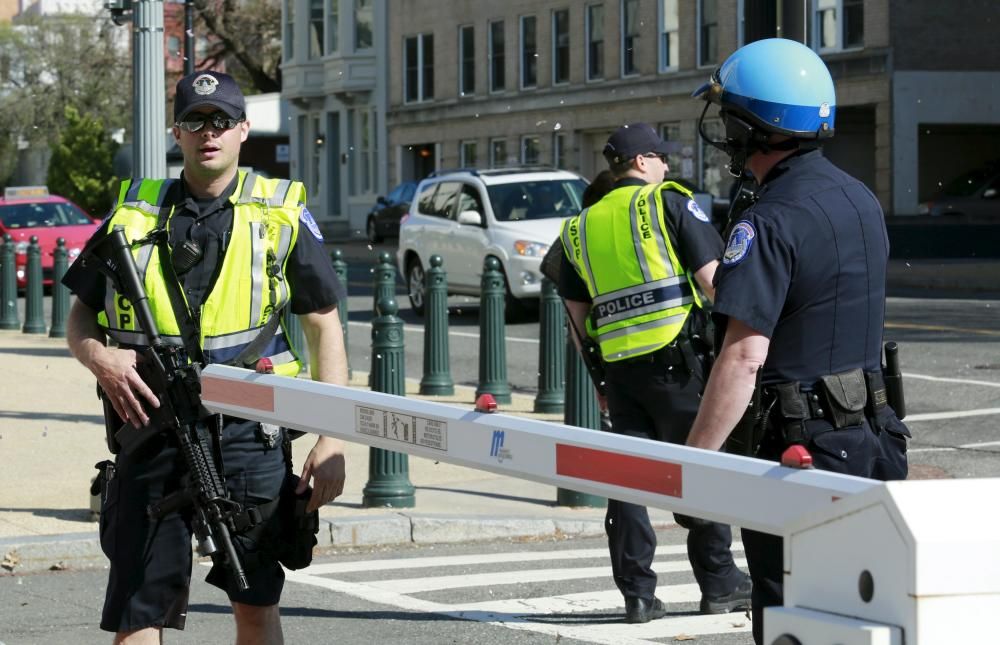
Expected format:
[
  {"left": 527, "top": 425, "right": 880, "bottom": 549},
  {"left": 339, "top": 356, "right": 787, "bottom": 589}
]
[{"left": 64, "top": 71, "right": 347, "bottom": 643}]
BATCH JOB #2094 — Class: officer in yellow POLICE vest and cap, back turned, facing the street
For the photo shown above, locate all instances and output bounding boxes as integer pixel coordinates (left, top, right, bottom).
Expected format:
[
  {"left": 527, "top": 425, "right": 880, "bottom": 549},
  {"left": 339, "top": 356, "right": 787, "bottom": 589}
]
[{"left": 559, "top": 123, "right": 750, "bottom": 623}]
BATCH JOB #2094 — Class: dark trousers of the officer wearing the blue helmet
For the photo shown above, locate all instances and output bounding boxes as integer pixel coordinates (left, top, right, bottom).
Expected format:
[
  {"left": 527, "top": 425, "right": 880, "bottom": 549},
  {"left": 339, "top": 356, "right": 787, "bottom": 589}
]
[{"left": 742, "top": 408, "right": 910, "bottom": 645}]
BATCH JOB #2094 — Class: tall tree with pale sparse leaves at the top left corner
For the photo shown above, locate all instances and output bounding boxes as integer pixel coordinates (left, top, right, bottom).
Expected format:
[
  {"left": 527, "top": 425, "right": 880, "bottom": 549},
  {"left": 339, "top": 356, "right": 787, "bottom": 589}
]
[{"left": 0, "top": 12, "right": 132, "bottom": 185}]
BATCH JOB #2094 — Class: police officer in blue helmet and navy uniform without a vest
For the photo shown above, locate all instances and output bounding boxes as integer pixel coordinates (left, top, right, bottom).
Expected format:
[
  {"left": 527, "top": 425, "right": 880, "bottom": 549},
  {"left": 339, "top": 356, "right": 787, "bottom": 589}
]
[{"left": 688, "top": 38, "right": 909, "bottom": 643}]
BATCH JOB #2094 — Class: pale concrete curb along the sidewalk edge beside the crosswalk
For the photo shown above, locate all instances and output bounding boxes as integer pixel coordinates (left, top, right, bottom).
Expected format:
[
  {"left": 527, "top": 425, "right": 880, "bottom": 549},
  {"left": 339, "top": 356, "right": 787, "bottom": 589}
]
[{"left": 0, "top": 513, "right": 674, "bottom": 575}]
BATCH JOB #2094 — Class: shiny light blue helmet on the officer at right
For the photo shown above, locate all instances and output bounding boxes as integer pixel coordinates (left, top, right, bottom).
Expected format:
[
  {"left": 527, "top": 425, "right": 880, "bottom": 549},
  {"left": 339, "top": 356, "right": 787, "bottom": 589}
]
[{"left": 693, "top": 38, "right": 837, "bottom": 139}]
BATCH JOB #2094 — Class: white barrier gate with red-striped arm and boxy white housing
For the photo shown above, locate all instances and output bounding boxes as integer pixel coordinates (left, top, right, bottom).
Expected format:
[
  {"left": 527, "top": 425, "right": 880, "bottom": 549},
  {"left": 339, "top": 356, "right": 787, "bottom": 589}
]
[{"left": 202, "top": 365, "right": 1000, "bottom": 645}]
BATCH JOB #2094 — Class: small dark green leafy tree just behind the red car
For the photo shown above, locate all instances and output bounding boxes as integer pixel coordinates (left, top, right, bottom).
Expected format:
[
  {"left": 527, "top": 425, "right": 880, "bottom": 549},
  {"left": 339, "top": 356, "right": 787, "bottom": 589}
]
[{"left": 47, "top": 105, "right": 118, "bottom": 216}]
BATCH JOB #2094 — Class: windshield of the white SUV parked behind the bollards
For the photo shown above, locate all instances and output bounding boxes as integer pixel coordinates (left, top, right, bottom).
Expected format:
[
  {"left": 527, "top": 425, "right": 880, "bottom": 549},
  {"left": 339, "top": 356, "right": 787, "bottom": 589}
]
[{"left": 486, "top": 179, "right": 587, "bottom": 222}]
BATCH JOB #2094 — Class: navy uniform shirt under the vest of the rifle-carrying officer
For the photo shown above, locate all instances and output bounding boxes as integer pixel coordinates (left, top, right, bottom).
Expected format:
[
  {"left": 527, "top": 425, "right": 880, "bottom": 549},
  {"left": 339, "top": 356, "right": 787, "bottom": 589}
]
[{"left": 63, "top": 177, "right": 345, "bottom": 314}]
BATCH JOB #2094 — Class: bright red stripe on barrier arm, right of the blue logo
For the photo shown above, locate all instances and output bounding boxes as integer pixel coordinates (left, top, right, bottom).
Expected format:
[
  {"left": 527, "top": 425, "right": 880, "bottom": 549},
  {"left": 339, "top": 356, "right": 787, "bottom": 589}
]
[{"left": 556, "top": 443, "right": 684, "bottom": 497}]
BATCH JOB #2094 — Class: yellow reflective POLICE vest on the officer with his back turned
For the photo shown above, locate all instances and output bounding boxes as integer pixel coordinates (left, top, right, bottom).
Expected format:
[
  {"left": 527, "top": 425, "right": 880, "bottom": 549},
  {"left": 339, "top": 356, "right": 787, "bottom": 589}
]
[{"left": 561, "top": 182, "right": 701, "bottom": 362}]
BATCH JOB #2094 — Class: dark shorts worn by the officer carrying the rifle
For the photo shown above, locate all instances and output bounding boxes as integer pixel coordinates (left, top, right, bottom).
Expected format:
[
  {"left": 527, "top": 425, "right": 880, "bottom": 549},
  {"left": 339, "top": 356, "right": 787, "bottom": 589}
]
[{"left": 101, "top": 420, "right": 286, "bottom": 632}]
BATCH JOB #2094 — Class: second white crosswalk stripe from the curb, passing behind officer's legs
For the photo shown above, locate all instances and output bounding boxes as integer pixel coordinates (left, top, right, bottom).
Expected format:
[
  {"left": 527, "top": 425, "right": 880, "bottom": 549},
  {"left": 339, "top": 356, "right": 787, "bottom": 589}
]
[{"left": 366, "top": 558, "right": 746, "bottom": 593}]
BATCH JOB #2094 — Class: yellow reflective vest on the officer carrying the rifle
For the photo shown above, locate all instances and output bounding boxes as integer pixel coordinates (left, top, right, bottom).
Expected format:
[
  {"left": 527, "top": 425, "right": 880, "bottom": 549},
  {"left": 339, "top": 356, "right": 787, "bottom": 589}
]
[{"left": 98, "top": 171, "right": 306, "bottom": 376}]
